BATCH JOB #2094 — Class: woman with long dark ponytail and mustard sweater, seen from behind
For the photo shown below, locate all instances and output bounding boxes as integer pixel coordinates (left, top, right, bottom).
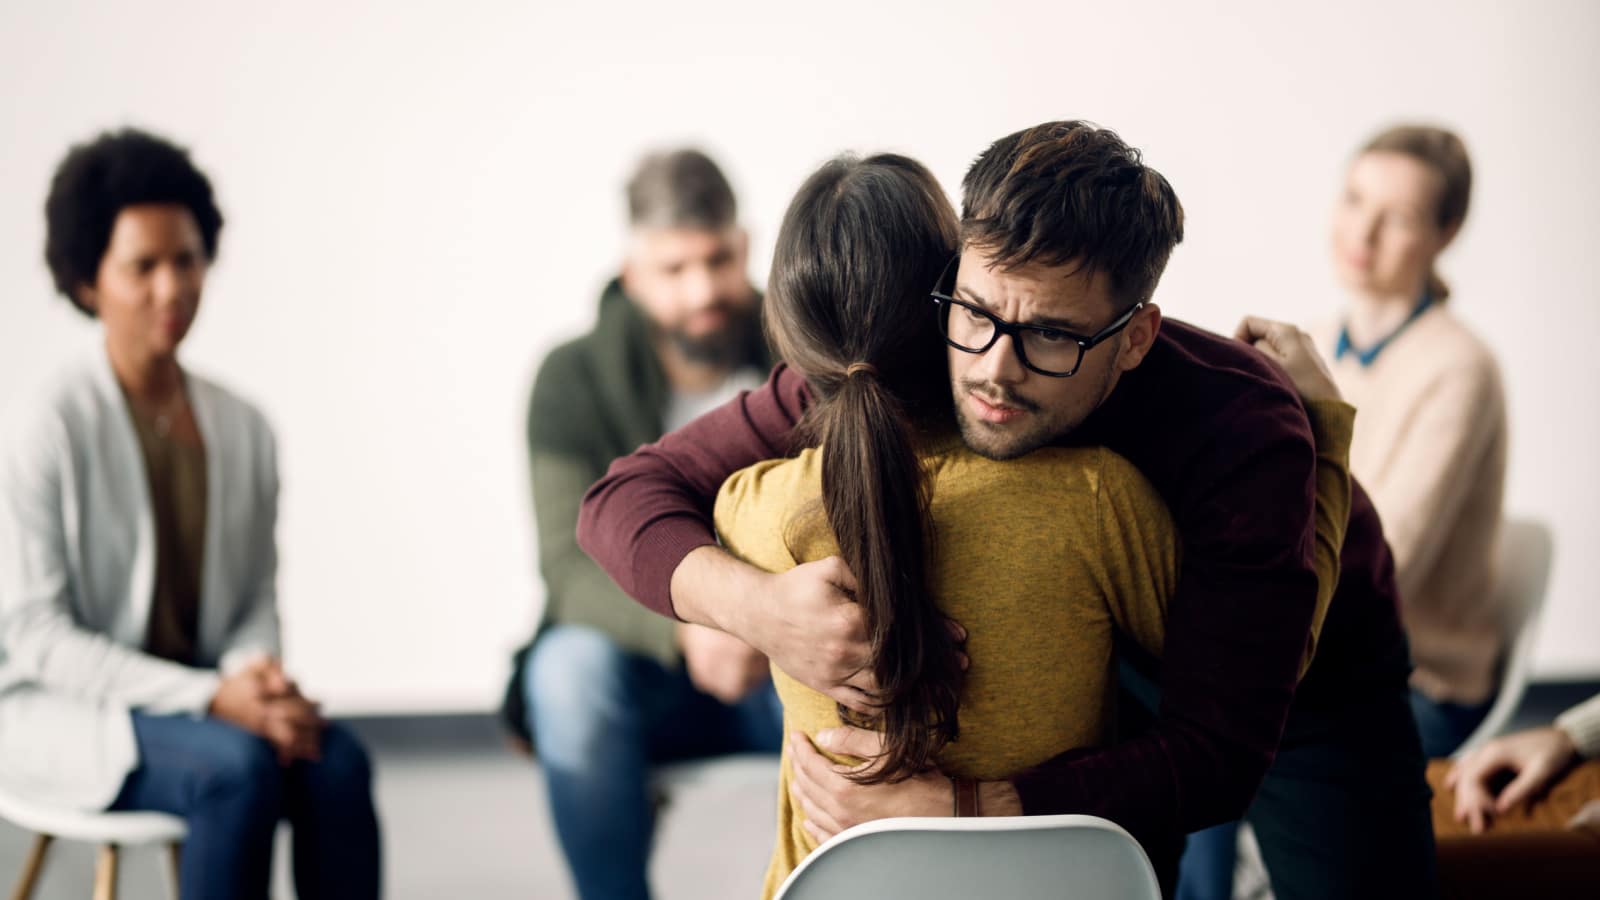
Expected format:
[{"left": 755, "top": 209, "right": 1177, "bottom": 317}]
[{"left": 715, "top": 155, "right": 1349, "bottom": 897}]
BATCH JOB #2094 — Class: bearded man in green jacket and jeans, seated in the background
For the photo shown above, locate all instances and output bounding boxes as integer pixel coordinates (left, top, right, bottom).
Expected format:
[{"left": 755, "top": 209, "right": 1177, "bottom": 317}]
[{"left": 502, "top": 151, "right": 782, "bottom": 900}]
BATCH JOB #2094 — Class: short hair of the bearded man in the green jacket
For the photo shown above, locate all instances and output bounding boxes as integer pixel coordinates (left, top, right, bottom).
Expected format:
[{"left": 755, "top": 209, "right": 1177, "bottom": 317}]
[{"left": 627, "top": 149, "right": 739, "bottom": 231}]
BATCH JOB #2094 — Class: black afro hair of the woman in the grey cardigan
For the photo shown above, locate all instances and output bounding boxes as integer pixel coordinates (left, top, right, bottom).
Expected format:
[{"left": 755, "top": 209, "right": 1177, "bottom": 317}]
[{"left": 45, "top": 128, "right": 222, "bottom": 319}]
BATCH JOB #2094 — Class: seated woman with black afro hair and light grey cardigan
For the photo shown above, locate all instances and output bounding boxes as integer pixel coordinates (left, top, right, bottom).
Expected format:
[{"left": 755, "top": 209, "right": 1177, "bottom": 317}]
[{"left": 0, "top": 130, "right": 379, "bottom": 900}]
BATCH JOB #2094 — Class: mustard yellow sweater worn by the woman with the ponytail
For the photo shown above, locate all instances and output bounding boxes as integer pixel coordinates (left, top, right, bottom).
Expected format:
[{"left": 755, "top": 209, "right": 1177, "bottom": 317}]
[{"left": 715, "top": 404, "right": 1354, "bottom": 897}]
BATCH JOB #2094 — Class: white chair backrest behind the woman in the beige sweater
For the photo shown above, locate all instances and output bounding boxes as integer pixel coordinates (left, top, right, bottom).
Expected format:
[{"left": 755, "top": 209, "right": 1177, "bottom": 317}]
[{"left": 1454, "top": 519, "right": 1555, "bottom": 757}]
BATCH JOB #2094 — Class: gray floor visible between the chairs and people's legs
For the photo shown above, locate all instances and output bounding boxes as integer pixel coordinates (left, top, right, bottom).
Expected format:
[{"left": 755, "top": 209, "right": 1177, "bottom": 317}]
[{"left": 0, "top": 682, "right": 1600, "bottom": 900}]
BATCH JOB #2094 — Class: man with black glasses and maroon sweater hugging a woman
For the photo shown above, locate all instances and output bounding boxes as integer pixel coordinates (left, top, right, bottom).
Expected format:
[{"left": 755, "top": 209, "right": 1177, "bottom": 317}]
[{"left": 578, "top": 122, "right": 1434, "bottom": 900}]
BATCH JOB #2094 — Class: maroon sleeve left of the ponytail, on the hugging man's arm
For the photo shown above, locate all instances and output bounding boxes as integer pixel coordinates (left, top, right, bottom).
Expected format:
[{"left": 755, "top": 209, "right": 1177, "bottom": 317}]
[{"left": 578, "top": 365, "right": 808, "bottom": 617}]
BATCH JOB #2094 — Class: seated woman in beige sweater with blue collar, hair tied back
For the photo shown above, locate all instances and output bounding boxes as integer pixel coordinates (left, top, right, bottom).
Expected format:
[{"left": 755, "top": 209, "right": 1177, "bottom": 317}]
[{"left": 1318, "top": 125, "right": 1507, "bottom": 757}]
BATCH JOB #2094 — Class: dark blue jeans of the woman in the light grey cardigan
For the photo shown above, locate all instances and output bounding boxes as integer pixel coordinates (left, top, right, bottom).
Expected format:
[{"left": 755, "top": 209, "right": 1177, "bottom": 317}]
[{"left": 110, "top": 711, "right": 379, "bottom": 900}]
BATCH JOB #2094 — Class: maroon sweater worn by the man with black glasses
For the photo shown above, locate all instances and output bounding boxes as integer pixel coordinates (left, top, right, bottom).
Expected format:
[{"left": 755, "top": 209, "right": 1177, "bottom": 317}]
[{"left": 578, "top": 319, "right": 1406, "bottom": 836}]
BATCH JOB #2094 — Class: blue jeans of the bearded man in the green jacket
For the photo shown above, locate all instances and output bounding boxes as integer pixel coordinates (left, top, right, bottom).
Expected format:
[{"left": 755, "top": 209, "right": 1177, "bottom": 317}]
[{"left": 525, "top": 625, "right": 782, "bottom": 900}]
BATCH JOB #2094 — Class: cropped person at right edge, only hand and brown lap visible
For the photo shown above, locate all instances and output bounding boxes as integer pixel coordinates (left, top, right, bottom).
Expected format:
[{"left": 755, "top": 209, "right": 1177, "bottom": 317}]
[{"left": 1427, "top": 685, "right": 1600, "bottom": 897}]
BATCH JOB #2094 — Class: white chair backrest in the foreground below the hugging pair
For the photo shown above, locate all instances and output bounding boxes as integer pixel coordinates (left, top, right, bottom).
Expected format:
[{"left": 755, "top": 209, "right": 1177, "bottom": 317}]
[{"left": 776, "top": 815, "right": 1162, "bottom": 900}]
